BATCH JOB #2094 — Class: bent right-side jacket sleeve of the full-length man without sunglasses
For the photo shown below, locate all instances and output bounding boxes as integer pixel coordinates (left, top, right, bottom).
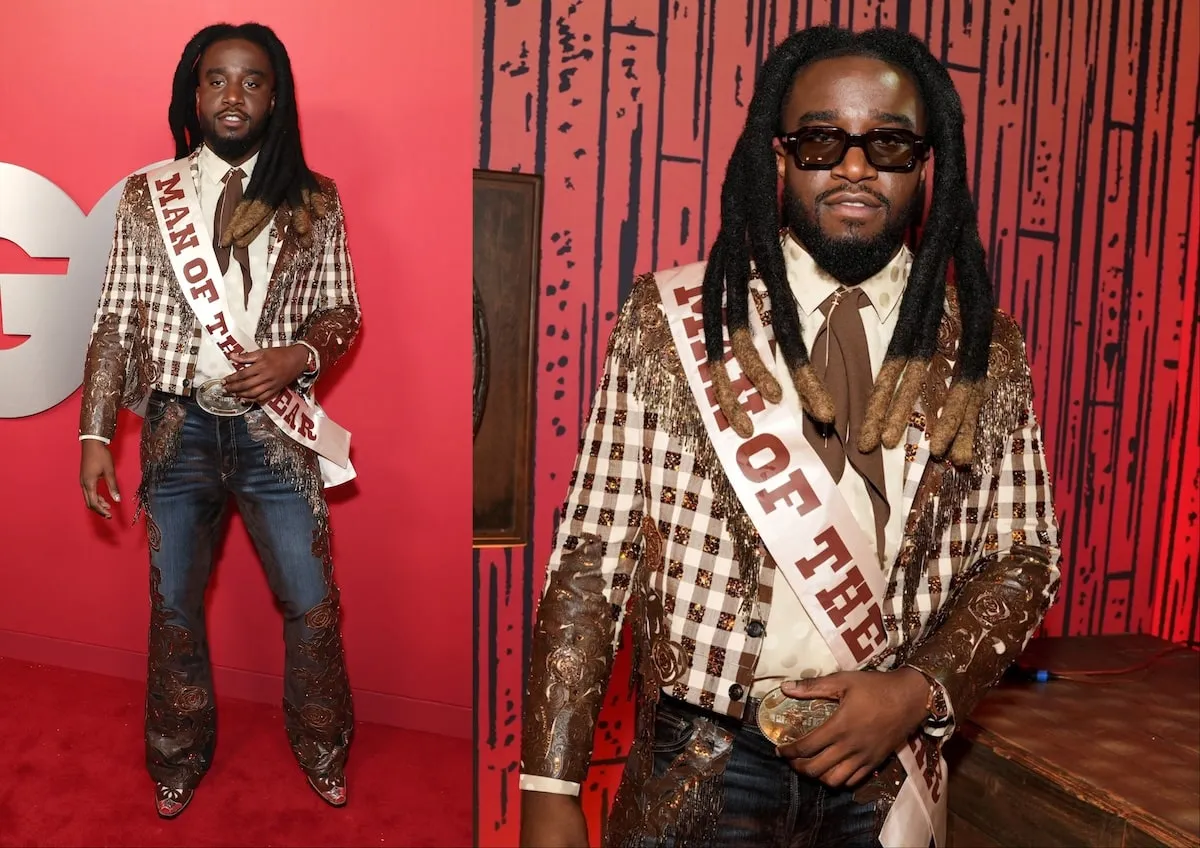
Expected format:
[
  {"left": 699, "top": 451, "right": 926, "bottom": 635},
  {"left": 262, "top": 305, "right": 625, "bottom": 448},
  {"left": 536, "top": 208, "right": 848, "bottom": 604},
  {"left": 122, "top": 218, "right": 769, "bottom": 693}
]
[{"left": 298, "top": 178, "right": 362, "bottom": 372}]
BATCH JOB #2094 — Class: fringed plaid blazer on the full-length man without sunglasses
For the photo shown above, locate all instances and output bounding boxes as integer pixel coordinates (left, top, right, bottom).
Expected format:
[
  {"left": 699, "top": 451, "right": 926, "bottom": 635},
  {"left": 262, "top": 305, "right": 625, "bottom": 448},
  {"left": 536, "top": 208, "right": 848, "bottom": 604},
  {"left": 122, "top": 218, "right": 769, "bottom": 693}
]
[{"left": 79, "top": 149, "right": 361, "bottom": 439}]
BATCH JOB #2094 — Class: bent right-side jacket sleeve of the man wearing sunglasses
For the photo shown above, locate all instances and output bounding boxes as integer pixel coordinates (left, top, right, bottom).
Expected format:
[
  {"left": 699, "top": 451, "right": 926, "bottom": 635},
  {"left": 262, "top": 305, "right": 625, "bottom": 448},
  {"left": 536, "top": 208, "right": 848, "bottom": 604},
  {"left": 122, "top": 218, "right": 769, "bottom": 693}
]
[{"left": 906, "top": 317, "right": 1060, "bottom": 738}]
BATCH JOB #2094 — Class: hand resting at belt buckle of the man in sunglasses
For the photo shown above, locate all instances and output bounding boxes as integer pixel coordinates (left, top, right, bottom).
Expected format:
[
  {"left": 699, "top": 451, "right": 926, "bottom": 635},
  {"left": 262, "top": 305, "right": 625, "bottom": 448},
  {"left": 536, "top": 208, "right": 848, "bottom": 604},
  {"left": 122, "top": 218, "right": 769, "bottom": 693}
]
[{"left": 779, "top": 668, "right": 929, "bottom": 787}]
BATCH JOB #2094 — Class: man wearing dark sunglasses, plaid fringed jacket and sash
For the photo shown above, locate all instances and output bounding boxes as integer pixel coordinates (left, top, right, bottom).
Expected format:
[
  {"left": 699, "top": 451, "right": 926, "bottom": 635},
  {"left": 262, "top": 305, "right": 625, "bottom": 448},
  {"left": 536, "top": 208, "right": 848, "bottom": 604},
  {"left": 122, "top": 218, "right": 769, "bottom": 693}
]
[{"left": 521, "top": 28, "right": 1058, "bottom": 848}]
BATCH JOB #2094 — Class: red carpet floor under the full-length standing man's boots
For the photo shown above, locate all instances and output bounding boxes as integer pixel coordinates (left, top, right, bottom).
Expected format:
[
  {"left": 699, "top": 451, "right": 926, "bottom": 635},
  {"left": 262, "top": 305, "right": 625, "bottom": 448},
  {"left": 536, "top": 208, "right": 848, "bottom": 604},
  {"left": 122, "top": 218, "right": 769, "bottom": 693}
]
[{"left": 0, "top": 657, "right": 472, "bottom": 847}]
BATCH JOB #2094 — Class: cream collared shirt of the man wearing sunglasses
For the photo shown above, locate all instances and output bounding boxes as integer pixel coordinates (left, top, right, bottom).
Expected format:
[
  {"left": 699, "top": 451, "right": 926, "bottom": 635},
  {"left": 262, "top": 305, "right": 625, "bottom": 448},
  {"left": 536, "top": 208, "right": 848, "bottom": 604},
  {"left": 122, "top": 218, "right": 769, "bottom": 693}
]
[{"left": 750, "top": 236, "right": 912, "bottom": 697}]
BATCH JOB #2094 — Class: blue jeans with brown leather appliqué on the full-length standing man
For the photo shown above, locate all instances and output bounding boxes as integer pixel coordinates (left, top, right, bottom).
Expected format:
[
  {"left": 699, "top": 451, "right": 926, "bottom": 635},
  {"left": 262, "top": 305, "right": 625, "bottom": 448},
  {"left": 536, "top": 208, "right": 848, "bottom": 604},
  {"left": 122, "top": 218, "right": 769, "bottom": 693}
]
[{"left": 139, "top": 392, "right": 353, "bottom": 788}]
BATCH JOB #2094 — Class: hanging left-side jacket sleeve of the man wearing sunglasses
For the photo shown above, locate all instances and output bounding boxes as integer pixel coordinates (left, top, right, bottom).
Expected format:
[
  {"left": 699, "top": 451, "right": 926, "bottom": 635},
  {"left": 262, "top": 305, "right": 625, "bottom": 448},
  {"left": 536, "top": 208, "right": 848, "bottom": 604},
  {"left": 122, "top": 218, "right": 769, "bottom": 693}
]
[{"left": 521, "top": 286, "right": 643, "bottom": 788}]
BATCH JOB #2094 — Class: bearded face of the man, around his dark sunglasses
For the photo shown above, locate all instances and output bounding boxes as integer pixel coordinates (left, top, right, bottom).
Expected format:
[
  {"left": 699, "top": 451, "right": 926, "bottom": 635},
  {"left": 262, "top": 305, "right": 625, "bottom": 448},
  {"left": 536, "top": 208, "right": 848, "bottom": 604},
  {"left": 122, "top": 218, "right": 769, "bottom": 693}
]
[{"left": 775, "top": 56, "right": 925, "bottom": 285}]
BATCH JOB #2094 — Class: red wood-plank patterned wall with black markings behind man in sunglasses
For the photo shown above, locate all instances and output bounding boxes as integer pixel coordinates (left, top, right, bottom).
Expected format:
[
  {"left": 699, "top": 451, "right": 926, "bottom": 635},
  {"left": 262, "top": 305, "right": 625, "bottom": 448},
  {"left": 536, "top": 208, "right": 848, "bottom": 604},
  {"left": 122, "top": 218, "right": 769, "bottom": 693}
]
[{"left": 474, "top": 0, "right": 1200, "bottom": 846}]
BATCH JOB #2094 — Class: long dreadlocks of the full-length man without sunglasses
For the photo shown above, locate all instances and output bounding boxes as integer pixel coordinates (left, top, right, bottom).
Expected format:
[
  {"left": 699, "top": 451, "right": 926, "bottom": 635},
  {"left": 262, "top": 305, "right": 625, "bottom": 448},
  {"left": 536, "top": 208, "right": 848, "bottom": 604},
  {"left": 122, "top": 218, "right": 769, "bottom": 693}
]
[{"left": 167, "top": 24, "right": 328, "bottom": 247}]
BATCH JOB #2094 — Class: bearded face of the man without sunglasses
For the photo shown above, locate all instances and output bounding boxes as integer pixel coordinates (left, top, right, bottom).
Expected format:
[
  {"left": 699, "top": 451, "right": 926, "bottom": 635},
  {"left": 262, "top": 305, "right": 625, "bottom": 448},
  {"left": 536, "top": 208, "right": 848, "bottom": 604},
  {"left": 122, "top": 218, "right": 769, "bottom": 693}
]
[{"left": 196, "top": 38, "right": 275, "bottom": 164}]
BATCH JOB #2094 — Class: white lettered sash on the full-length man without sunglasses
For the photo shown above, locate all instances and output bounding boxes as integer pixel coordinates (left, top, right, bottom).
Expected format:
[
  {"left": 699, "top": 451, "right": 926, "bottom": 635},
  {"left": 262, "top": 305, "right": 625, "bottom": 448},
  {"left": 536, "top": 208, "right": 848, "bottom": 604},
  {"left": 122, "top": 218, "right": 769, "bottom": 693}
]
[{"left": 146, "top": 160, "right": 353, "bottom": 485}]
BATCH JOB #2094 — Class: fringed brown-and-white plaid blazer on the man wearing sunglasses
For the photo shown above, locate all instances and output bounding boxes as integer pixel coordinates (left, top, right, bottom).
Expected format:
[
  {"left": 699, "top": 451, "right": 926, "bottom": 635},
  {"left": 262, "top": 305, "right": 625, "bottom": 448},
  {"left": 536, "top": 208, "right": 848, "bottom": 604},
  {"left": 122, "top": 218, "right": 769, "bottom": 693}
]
[{"left": 522, "top": 265, "right": 1060, "bottom": 782}]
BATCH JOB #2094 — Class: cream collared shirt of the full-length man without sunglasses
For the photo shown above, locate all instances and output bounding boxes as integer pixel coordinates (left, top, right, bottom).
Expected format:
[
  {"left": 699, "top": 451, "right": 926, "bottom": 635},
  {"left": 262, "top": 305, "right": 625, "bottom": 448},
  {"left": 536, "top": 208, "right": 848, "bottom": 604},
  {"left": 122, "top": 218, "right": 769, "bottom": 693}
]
[{"left": 194, "top": 144, "right": 271, "bottom": 386}]
